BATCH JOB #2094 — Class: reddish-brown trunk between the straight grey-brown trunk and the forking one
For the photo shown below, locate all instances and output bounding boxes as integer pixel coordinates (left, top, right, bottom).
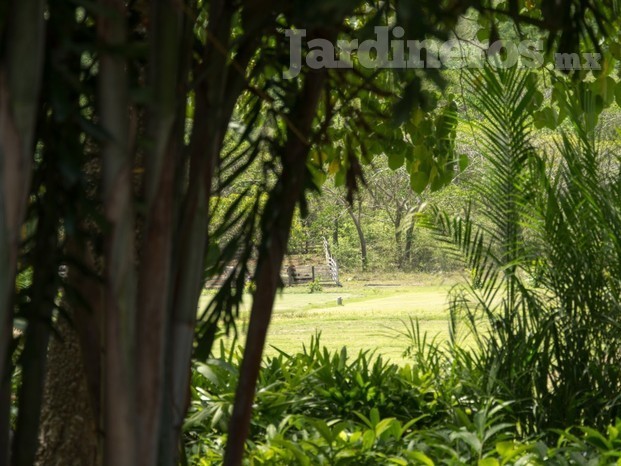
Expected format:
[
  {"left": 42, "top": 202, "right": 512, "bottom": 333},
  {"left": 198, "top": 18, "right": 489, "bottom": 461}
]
[{"left": 136, "top": 0, "right": 182, "bottom": 466}]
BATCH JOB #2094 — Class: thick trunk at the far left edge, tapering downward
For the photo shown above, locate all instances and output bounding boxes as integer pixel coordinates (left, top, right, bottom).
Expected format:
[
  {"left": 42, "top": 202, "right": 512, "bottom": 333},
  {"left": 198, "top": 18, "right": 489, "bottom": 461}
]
[{"left": 0, "top": 0, "right": 45, "bottom": 466}]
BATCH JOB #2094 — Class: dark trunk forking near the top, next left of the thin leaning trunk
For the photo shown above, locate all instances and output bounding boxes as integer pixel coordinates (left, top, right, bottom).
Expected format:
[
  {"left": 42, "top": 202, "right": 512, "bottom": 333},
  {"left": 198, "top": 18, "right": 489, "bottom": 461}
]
[{"left": 161, "top": 5, "right": 262, "bottom": 464}]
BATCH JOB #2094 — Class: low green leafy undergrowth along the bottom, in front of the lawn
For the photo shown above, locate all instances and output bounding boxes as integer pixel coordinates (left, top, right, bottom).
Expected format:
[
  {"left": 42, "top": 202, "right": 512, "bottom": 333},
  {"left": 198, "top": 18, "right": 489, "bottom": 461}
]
[{"left": 185, "top": 334, "right": 621, "bottom": 466}]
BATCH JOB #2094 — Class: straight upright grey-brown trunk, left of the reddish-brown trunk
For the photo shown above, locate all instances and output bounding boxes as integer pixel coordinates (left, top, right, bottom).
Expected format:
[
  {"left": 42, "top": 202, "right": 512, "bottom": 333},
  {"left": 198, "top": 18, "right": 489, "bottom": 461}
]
[{"left": 98, "top": 0, "right": 138, "bottom": 466}]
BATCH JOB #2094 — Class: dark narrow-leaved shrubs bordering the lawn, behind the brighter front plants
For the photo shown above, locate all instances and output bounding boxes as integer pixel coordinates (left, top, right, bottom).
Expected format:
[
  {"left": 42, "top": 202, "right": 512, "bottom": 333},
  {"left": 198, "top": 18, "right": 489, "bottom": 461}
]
[{"left": 187, "top": 336, "right": 441, "bottom": 432}]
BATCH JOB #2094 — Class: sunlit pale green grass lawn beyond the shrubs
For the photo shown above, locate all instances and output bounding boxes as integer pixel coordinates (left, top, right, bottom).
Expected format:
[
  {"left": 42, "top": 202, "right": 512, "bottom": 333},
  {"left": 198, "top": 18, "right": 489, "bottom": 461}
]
[{"left": 206, "top": 275, "right": 456, "bottom": 362}]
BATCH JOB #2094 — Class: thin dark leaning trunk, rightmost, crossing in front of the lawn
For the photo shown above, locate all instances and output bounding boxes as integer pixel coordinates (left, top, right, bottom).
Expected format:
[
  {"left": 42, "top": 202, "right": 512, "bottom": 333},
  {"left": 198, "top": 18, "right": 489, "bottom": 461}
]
[{"left": 224, "top": 62, "right": 326, "bottom": 466}]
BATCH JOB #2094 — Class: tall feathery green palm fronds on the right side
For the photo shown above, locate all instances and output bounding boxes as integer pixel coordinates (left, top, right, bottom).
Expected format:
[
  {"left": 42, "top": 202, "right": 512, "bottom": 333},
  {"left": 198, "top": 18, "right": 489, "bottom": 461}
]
[{"left": 434, "top": 66, "right": 621, "bottom": 431}]
